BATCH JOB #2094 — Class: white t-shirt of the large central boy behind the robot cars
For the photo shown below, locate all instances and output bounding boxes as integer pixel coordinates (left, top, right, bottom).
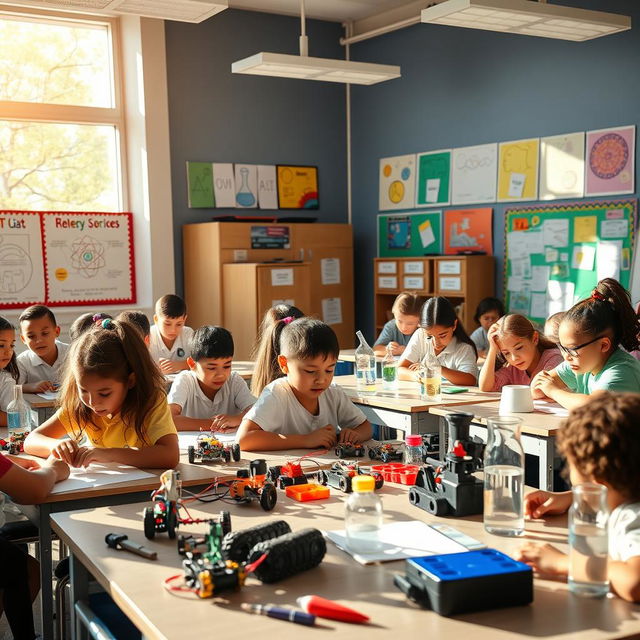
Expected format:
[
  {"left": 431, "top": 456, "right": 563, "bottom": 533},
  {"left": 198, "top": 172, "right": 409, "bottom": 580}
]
[{"left": 245, "top": 378, "right": 366, "bottom": 435}]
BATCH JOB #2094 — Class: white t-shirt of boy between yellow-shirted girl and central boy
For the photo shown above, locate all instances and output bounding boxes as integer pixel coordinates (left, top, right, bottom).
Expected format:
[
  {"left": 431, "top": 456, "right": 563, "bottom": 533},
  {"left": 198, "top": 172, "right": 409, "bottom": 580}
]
[{"left": 167, "top": 371, "right": 256, "bottom": 420}]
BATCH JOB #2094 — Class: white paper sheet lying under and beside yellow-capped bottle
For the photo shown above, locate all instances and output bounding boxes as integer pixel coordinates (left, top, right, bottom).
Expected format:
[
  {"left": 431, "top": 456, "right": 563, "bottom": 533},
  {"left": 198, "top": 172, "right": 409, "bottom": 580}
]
[{"left": 324, "top": 520, "right": 467, "bottom": 564}]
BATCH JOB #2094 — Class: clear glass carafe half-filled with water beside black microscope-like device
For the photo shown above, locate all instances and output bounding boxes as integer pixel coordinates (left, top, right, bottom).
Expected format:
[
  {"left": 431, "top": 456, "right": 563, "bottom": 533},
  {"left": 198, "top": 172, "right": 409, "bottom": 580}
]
[{"left": 484, "top": 416, "right": 524, "bottom": 536}]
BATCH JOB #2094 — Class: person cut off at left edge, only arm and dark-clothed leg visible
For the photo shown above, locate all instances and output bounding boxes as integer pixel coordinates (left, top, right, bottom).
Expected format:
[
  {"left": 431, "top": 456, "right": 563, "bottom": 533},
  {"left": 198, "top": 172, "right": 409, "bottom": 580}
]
[{"left": 0, "top": 453, "right": 69, "bottom": 640}]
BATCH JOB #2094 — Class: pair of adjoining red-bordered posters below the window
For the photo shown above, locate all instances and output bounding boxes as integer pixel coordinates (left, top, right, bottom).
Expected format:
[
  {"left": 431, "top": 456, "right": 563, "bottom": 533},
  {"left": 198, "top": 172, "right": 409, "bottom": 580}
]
[{"left": 0, "top": 211, "right": 136, "bottom": 309}]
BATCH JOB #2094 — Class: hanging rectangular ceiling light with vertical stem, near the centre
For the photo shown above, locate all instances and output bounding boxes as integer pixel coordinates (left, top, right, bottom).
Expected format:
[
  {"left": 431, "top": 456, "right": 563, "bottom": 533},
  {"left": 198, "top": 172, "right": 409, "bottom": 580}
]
[{"left": 231, "top": 0, "right": 400, "bottom": 85}]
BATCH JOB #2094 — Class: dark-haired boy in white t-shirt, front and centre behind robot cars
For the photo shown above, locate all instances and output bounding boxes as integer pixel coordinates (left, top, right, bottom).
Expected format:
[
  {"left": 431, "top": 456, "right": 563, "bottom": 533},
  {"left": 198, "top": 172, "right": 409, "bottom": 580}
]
[{"left": 237, "top": 318, "right": 371, "bottom": 451}]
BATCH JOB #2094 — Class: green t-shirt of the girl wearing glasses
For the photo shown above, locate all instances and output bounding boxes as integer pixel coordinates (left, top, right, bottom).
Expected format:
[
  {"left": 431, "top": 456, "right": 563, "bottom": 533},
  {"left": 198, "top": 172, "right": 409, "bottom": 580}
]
[{"left": 556, "top": 348, "right": 640, "bottom": 395}]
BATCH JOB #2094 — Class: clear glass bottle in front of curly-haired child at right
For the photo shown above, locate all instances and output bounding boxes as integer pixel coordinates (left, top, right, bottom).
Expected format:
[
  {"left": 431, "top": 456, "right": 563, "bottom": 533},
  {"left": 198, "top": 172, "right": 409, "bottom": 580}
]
[{"left": 569, "top": 483, "right": 609, "bottom": 598}]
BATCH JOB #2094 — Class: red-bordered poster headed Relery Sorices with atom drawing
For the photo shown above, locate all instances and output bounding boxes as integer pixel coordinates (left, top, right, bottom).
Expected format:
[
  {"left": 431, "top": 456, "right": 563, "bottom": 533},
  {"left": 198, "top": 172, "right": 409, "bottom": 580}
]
[{"left": 40, "top": 212, "right": 136, "bottom": 305}]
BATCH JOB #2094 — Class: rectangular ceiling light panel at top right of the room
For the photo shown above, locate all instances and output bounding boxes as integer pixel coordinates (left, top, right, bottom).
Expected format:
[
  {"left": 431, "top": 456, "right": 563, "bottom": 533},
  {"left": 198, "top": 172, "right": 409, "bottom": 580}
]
[{"left": 421, "top": 0, "right": 631, "bottom": 42}]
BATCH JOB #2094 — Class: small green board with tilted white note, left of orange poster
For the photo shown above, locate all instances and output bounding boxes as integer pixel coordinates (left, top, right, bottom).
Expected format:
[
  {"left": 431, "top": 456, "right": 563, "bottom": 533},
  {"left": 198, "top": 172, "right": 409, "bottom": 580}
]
[{"left": 378, "top": 210, "right": 442, "bottom": 258}]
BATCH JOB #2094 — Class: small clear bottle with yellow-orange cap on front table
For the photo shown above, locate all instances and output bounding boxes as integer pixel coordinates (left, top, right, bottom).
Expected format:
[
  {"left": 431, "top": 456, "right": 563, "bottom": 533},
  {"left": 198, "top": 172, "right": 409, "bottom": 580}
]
[{"left": 344, "top": 475, "right": 383, "bottom": 553}]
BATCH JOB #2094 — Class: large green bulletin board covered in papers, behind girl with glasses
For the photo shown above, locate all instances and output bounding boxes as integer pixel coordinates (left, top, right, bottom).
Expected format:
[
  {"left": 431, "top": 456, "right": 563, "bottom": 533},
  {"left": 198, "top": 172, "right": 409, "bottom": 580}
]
[{"left": 504, "top": 199, "right": 638, "bottom": 324}]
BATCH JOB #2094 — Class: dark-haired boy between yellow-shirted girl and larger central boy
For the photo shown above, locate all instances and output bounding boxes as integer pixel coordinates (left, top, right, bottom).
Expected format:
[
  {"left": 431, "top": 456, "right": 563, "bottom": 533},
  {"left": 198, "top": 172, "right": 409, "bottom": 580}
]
[{"left": 168, "top": 326, "right": 256, "bottom": 431}]
